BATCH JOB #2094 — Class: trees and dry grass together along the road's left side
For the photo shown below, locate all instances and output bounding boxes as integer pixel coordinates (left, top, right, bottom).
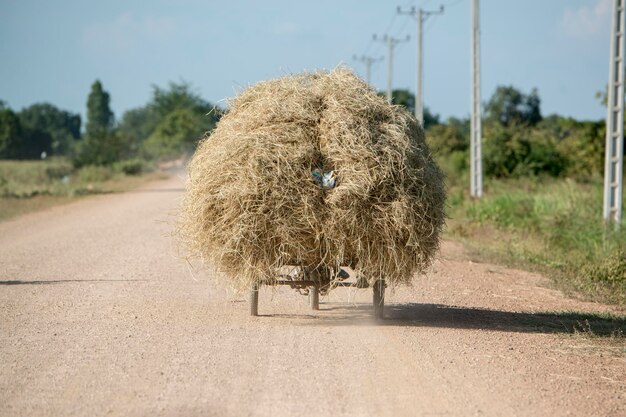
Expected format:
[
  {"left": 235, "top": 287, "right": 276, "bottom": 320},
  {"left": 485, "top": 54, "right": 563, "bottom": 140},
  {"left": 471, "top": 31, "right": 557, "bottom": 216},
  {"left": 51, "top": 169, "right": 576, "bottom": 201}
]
[{"left": 0, "top": 80, "right": 220, "bottom": 220}]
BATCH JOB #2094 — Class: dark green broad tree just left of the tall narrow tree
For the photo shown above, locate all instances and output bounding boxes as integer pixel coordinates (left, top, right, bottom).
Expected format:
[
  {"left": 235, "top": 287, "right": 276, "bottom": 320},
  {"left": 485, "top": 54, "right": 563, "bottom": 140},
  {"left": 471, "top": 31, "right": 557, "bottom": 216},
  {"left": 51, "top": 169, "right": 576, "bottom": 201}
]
[{"left": 19, "top": 103, "right": 81, "bottom": 155}]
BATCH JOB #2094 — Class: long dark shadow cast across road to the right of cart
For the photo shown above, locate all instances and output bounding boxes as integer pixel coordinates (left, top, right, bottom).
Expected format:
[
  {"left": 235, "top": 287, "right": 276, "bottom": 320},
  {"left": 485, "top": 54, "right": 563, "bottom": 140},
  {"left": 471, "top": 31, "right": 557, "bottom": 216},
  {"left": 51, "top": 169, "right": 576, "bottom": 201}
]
[{"left": 298, "top": 303, "right": 626, "bottom": 337}]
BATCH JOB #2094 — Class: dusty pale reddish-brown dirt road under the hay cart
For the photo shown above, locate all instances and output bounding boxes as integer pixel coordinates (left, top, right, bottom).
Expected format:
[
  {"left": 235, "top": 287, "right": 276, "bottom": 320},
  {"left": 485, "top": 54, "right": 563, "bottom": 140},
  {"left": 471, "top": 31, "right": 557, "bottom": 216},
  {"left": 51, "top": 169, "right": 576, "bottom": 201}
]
[{"left": 0, "top": 173, "right": 626, "bottom": 417}]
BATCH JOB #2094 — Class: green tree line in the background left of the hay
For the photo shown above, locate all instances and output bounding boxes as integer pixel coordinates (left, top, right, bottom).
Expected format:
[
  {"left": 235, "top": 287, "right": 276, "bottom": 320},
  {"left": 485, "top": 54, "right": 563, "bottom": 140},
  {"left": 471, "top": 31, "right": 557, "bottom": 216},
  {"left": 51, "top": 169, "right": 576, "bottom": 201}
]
[{"left": 0, "top": 80, "right": 221, "bottom": 167}]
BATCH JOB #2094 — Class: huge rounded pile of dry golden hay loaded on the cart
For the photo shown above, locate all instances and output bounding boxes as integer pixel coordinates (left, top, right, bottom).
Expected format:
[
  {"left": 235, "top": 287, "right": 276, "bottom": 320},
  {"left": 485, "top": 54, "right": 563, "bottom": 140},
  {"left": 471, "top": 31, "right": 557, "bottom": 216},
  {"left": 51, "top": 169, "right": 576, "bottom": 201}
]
[{"left": 179, "top": 68, "right": 445, "bottom": 288}]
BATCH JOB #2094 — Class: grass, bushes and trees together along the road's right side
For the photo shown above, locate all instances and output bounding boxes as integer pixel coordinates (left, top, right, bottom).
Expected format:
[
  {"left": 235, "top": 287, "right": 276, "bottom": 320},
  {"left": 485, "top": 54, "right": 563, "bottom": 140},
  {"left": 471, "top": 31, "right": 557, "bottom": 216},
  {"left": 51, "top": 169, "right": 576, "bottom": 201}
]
[{"left": 416, "top": 87, "right": 626, "bottom": 306}]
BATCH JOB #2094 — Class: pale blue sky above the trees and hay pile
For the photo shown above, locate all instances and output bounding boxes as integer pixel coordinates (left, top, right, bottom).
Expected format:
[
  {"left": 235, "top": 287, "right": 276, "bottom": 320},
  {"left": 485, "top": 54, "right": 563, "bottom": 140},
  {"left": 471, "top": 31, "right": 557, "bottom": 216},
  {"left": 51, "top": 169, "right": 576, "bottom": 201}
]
[{"left": 0, "top": 0, "right": 611, "bottom": 119}]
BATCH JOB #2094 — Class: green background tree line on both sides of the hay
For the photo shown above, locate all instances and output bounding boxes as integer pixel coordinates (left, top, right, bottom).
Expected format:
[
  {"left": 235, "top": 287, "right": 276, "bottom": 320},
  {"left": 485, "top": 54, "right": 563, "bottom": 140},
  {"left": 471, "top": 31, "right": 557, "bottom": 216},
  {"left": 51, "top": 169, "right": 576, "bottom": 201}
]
[{"left": 0, "top": 80, "right": 616, "bottom": 179}]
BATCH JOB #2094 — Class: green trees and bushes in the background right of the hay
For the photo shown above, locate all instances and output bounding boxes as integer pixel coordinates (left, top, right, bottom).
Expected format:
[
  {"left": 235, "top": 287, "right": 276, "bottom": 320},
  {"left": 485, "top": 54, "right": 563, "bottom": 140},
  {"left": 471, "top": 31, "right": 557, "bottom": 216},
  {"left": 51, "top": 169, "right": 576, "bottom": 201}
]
[{"left": 393, "top": 86, "right": 606, "bottom": 181}]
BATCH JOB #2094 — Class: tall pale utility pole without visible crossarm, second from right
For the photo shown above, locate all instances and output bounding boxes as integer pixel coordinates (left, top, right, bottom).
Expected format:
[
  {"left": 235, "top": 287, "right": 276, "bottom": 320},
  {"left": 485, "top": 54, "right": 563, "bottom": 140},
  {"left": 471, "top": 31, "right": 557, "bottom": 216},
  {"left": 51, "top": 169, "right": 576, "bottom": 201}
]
[{"left": 470, "top": 0, "right": 483, "bottom": 198}]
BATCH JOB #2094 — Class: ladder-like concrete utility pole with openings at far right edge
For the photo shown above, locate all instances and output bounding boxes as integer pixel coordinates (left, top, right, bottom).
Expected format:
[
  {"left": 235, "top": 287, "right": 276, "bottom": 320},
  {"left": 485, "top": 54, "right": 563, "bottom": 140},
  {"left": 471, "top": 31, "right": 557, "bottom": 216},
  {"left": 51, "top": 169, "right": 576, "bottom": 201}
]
[{"left": 603, "top": 0, "right": 626, "bottom": 228}]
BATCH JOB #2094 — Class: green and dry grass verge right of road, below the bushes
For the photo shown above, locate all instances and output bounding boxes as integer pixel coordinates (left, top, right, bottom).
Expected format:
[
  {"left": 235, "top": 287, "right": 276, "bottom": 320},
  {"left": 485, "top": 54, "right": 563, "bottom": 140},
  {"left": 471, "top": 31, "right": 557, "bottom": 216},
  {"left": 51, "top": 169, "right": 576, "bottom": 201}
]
[{"left": 448, "top": 172, "right": 626, "bottom": 305}]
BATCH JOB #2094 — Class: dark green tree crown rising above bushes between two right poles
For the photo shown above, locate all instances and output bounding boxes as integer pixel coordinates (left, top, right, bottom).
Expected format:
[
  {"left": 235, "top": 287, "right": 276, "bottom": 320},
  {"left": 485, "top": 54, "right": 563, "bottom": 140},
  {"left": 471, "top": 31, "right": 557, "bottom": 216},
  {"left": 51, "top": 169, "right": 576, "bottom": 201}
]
[{"left": 485, "top": 86, "right": 542, "bottom": 126}]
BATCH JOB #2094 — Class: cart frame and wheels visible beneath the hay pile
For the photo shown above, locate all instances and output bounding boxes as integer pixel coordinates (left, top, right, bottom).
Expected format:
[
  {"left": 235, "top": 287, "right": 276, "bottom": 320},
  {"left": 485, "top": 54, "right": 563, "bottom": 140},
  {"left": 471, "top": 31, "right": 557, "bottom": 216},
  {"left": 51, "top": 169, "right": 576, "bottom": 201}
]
[{"left": 250, "top": 262, "right": 386, "bottom": 319}]
